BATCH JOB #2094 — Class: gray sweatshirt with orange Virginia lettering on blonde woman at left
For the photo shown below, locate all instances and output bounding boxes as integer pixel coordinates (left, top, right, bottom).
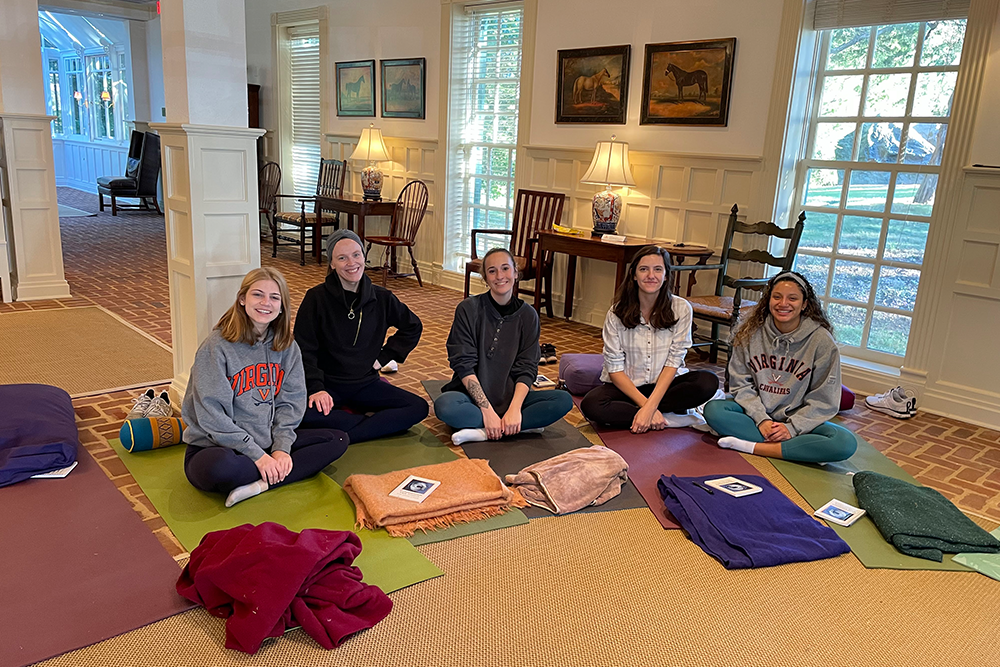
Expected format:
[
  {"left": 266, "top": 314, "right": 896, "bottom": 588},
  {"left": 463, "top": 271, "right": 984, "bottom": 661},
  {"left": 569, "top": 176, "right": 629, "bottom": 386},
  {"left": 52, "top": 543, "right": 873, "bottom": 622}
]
[{"left": 181, "top": 329, "right": 306, "bottom": 461}]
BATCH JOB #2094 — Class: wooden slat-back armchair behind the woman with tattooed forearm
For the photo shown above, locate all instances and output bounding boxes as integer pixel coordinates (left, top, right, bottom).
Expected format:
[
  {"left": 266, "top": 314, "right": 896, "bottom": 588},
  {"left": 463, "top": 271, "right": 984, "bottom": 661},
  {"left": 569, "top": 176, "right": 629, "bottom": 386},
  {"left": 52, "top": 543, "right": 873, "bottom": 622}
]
[{"left": 465, "top": 185, "right": 566, "bottom": 317}]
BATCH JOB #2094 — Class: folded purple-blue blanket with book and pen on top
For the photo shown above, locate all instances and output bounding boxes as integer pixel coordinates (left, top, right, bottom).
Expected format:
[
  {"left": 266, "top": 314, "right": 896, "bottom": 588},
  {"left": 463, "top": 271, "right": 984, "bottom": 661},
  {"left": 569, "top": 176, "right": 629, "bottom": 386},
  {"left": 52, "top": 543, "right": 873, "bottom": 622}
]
[{"left": 656, "top": 475, "right": 851, "bottom": 570}]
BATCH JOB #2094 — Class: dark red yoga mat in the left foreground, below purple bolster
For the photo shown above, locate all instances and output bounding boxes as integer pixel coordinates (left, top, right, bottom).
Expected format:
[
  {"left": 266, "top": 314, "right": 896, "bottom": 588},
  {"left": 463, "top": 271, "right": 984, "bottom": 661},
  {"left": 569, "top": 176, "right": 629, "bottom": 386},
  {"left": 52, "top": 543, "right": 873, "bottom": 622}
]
[{"left": 0, "top": 447, "right": 194, "bottom": 667}]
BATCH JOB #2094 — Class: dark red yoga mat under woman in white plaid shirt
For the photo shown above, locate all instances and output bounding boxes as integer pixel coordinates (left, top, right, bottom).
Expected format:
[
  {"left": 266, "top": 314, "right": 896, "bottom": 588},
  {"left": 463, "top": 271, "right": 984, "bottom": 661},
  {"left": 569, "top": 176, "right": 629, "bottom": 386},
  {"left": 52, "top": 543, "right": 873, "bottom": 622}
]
[{"left": 574, "top": 397, "right": 760, "bottom": 529}]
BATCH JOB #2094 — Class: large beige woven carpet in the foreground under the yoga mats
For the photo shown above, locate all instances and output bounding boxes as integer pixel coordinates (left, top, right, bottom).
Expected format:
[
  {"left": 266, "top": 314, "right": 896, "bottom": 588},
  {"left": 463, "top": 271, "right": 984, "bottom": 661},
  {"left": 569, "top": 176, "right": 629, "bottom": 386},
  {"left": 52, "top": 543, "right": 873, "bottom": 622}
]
[{"left": 31, "top": 457, "right": 1000, "bottom": 667}]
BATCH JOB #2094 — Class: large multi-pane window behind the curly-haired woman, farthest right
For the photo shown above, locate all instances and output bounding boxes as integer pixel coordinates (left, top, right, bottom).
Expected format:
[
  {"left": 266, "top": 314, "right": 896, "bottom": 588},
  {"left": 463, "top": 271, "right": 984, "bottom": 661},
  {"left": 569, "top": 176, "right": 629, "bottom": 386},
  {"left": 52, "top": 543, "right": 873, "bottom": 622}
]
[{"left": 795, "top": 19, "right": 965, "bottom": 365}]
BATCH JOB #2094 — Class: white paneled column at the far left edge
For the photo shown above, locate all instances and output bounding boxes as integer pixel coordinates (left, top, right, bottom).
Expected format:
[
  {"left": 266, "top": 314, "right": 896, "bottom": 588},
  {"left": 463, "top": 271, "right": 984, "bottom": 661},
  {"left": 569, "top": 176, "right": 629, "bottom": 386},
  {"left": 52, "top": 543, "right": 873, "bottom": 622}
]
[{"left": 0, "top": 0, "right": 69, "bottom": 301}]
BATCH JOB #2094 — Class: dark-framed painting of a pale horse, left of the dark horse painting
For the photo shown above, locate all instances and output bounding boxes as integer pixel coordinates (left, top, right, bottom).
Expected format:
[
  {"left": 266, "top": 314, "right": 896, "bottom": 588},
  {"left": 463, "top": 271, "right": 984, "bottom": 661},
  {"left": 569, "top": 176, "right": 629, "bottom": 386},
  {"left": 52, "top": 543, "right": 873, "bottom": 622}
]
[{"left": 556, "top": 44, "right": 632, "bottom": 125}]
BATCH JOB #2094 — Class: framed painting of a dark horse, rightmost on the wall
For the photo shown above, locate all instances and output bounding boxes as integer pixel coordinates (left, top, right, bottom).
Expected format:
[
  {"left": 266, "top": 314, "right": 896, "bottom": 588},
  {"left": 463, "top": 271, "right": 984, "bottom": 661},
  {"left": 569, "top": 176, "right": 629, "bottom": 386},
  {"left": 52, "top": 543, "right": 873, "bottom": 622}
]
[{"left": 639, "top": 37, "right": 736, "bottom": 126}]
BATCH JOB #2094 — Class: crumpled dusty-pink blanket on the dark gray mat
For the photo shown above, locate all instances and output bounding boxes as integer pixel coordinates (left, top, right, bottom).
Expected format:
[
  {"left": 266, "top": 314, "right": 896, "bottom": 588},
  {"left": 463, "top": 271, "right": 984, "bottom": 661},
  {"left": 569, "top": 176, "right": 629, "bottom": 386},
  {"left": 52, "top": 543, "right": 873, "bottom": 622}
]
[{"left": 506, "top": 445, "right": 628, "bottom": 514}]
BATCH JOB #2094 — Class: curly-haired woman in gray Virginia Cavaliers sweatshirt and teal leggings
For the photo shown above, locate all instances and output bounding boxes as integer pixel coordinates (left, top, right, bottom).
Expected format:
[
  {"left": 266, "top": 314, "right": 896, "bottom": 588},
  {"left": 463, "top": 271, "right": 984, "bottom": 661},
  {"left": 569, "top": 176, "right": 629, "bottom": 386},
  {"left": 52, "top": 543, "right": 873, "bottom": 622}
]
[{"left": 705, "top": 271, "right": 858, "bottom": 463}]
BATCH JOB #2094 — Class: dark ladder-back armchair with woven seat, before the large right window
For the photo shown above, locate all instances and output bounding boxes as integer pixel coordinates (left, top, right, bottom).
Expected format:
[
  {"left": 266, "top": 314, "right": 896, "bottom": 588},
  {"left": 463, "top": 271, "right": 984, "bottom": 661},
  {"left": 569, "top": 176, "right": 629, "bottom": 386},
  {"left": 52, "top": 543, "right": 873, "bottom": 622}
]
[{"left": 684, "top": 204, "right": 806, "bottom": 374}]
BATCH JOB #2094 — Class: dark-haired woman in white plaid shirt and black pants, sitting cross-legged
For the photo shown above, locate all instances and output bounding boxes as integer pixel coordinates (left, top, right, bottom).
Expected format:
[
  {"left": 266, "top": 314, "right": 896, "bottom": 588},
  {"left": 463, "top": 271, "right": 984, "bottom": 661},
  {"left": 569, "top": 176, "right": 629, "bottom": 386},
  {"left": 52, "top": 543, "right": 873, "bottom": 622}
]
[{"left": 580, "top": 246, "right": 719, "bottom": 433}]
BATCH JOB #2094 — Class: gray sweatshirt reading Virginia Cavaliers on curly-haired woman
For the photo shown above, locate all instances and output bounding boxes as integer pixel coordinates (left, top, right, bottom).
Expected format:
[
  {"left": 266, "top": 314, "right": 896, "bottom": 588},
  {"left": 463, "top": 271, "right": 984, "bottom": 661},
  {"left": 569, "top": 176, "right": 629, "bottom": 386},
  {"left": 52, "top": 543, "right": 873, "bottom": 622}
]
[{"left": 729, "top": 315, "right": 840, "bottom": 437}]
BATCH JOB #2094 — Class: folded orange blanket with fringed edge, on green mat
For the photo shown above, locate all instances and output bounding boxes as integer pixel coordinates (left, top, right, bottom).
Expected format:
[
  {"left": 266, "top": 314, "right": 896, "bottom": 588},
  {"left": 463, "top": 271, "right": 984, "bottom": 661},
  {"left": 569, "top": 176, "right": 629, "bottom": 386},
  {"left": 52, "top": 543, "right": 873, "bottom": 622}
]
[{"left": 344, "top": 459, "right": 527, "bottom": 537}]
